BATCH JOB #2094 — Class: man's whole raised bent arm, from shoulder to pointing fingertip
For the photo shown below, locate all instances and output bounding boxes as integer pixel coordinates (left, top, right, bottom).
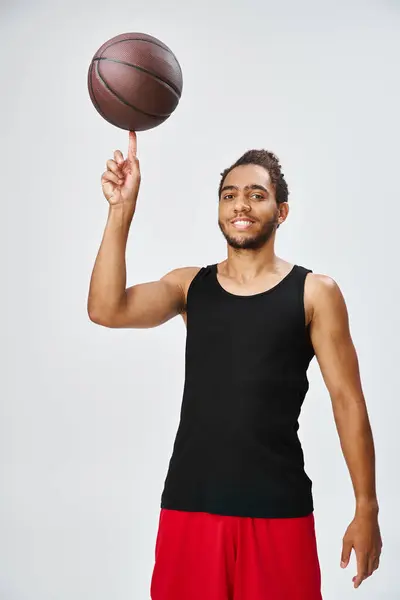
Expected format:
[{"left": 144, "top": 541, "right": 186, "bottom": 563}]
[{"left": 87, "top": 132, "right": 198, "bottom": 328}]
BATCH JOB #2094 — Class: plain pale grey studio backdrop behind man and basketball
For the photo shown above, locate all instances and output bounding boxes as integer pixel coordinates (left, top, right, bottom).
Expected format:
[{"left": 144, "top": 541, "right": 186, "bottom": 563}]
[{"left": 0, "top": 0, "right": 400, "bottom": 600}]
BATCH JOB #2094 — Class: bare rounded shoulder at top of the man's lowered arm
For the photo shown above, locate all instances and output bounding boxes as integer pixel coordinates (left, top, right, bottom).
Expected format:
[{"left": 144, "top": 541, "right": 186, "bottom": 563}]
[{"left": 304, "top": 273, "right": 346, "bottom": 320}]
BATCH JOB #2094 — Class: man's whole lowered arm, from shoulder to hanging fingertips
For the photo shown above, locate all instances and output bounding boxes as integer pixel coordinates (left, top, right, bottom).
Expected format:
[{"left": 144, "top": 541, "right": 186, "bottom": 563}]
[{"left": 306, "top": 274, "right": 382, "bottom": 588}]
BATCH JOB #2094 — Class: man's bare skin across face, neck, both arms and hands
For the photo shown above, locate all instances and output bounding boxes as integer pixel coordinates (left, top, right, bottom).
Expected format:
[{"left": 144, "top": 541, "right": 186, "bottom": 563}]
[{"left": 88, "top": 132, "right": 382, "bottom": 588}]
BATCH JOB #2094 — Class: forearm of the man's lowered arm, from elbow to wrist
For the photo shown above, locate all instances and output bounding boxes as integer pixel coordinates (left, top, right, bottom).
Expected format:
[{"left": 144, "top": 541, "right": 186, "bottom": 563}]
[{"left": 334, "top": 398, "right": 379, "bottom": 513}]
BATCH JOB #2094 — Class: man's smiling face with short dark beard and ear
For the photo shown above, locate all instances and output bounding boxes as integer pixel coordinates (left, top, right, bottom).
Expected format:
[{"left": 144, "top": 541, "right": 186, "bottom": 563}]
[{"left": 218, "top": 165, "right": 287, "bottom": 250}]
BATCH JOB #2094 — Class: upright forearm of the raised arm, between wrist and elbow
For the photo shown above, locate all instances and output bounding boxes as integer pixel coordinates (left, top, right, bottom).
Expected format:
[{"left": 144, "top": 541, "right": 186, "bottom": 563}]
[{"left": 88, "top": 204, "right": 134, "bottom": 320}]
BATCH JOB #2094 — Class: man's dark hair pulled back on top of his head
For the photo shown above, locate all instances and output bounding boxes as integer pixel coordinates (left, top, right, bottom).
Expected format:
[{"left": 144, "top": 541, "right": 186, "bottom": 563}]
[{"left": 218, "top": 150, "right": 289, "bottom": 204}]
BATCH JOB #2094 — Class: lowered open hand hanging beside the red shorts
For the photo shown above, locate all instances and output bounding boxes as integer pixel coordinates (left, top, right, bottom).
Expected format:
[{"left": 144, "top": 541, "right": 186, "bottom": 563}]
[{"left": 340, "top": 514, "right": 383, "bottom": 588}]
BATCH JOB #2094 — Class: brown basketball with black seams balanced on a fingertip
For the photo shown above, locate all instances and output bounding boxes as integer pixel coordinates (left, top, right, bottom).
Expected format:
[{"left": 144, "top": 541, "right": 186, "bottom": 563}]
[{"left": 88, "top": 33, "right": 182, "bottom": 131}]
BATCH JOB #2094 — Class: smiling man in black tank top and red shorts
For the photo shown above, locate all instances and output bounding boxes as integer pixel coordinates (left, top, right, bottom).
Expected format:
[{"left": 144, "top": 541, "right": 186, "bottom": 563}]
[{"left": 88, "top": 132, "right": 382, "bottom": 600}]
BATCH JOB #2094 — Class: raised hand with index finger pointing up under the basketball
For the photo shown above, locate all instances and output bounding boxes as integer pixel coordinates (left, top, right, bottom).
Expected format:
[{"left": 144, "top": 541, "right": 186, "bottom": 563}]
[{"left": 101, "top": 131, "right": 140, "bottom": 209}]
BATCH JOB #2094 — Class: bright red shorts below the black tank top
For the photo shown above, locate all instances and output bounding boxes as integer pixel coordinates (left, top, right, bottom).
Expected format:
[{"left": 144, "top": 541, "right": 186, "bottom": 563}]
[{"left": 151, "top": 508, "right": 322, "bottom": 600}]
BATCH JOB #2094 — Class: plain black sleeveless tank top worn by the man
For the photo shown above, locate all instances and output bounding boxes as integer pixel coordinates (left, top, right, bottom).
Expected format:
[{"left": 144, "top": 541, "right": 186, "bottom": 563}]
[{"left": 161, "top": 264, "right": 314, "bottom": 518}]
